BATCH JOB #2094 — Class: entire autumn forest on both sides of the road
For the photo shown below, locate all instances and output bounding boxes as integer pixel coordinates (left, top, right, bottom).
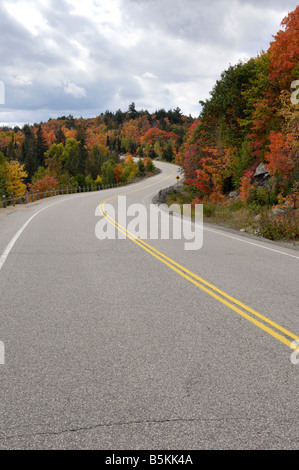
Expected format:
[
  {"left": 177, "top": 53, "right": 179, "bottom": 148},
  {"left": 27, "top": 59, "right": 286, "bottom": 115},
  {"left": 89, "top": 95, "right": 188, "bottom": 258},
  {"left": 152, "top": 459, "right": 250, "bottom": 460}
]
[{"left": 0, "top": 6, "right": 299, "bottom": 241}]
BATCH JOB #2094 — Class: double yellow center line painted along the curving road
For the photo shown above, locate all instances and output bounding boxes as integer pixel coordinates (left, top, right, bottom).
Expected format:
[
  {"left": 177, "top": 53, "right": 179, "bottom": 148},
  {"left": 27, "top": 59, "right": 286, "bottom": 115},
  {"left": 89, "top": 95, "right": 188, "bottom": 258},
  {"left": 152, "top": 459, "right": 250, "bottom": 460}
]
[{"left": 100, "top": 172, "right": 299, "bottom": 350}]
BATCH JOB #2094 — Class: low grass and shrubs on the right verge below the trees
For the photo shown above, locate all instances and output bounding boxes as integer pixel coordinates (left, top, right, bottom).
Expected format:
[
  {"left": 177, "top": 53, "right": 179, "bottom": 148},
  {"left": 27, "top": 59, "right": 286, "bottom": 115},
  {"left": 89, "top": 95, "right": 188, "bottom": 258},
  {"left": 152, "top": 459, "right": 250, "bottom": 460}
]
[{"left": 166, "top": 190, "right": 299, "bottom": 246}]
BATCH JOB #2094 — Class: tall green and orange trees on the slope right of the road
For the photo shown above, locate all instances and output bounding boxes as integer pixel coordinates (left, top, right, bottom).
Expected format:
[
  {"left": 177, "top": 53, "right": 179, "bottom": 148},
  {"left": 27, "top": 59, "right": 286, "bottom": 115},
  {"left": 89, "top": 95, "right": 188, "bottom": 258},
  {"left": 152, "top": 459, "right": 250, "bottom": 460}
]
[{"left": 176, "top": 7, "right": 299, "bottom": 207}]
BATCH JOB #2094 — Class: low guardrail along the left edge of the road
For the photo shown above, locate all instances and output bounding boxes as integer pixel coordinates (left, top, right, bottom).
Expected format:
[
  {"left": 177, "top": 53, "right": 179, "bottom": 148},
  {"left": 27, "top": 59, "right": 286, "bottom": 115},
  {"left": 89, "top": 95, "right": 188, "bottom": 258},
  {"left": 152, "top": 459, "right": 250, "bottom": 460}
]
[{"left": 0, "top": 181, "right": 133, "bottom": 209}]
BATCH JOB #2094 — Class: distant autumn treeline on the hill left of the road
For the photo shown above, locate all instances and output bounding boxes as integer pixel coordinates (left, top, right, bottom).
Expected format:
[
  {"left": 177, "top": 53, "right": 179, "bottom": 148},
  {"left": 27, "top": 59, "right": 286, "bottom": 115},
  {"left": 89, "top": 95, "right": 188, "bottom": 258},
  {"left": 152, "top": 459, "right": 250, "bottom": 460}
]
[{"left": 0, "top": 103, "right": 193, "bottom": 195}]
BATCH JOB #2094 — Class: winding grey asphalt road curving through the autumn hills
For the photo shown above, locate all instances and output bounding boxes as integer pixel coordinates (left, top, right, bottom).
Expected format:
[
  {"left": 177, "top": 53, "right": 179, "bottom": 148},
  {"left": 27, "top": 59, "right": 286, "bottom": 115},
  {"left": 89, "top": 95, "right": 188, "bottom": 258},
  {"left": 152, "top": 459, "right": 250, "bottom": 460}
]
[{"left": 0, "top": 163, "right": 299, "bottom": 450}]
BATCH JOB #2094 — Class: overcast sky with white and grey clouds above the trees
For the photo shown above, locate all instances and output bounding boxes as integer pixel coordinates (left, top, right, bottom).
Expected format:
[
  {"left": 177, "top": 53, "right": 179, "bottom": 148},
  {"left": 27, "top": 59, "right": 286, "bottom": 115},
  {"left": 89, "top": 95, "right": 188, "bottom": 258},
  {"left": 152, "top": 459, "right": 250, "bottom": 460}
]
[{"left": 0, "top": 0, "right": 298, "bottom": 125}]
